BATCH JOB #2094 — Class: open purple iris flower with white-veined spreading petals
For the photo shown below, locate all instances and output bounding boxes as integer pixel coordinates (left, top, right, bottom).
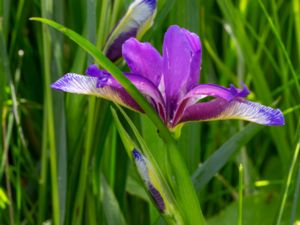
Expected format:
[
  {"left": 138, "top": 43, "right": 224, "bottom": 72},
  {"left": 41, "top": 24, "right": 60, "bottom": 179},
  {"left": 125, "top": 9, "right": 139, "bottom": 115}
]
[{"left": 52, "top": 25, "right": 284, "bottom": 129}]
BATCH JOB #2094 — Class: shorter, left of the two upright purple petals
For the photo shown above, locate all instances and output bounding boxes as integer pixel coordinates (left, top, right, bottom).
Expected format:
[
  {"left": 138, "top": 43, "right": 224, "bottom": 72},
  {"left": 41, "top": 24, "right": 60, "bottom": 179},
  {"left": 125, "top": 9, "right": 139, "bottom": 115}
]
[{"left": 122, "top": 38, "right": 162, "bottom": 86}]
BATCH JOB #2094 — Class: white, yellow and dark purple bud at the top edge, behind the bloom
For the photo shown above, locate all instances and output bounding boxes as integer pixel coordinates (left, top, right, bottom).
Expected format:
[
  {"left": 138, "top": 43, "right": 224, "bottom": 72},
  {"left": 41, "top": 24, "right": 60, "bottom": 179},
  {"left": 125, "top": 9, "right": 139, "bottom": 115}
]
[{"left": 104, "top": 0, "right": 156, "bottom": 61}]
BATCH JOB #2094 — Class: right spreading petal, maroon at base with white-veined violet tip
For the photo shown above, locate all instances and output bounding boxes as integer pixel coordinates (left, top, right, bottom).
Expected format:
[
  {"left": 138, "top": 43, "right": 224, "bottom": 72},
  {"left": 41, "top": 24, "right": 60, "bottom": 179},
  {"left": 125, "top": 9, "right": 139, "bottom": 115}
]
[{"left": 179, "top": 98, "right": 284, "bottom": 126}]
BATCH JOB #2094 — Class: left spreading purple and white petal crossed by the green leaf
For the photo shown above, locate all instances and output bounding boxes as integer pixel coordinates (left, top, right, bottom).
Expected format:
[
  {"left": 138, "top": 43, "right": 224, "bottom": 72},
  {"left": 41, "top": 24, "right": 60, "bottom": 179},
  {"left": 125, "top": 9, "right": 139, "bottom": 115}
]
[{"left": 51, "top": 71, "right": 165, "bottom": 119}]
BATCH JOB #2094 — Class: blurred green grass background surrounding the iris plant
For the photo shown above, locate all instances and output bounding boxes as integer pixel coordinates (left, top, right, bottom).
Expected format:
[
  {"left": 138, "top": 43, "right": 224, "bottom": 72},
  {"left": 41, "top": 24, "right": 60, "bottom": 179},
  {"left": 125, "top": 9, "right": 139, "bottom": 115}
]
[{"left": 0, "top": 0, "right": 300, "bottom": 225}]
